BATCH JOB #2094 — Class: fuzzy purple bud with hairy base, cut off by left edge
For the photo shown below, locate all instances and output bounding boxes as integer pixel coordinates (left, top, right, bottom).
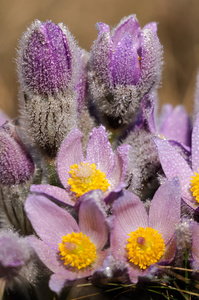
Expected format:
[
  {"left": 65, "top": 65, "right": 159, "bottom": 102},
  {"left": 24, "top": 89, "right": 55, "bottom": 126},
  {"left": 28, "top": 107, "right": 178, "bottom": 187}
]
[{"left": 0, "top": 121, "right": 35, "bottom": 234}]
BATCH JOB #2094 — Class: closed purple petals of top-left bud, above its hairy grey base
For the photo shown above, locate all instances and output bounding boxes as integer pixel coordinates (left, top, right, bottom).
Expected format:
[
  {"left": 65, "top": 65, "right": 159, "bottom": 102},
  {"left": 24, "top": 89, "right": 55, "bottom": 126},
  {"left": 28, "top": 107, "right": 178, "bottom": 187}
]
[{"left": 18, "top": 20, "right": 72, "bottom": 95}]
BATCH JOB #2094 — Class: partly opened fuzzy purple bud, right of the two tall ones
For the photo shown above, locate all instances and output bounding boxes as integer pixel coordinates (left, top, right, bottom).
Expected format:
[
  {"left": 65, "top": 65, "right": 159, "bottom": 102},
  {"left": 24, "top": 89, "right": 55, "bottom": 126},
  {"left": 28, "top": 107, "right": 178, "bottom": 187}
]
[{"left": 89, "top": 15, "right": 162, "bottom": 129}]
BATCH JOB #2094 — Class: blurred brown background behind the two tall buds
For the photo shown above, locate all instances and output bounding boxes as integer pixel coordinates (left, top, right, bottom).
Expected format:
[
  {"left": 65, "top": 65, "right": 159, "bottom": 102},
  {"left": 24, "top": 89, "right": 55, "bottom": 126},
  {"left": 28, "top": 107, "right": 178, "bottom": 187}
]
[{"left": 0, "top": 0, "right": 199, "bottom": 118}]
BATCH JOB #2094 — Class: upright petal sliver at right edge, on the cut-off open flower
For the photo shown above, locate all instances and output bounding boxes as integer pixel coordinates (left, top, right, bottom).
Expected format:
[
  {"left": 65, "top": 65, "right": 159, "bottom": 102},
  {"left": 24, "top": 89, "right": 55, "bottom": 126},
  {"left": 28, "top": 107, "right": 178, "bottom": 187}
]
[{"left": 191, "top": 115, "right": 199, "bottom": 173}]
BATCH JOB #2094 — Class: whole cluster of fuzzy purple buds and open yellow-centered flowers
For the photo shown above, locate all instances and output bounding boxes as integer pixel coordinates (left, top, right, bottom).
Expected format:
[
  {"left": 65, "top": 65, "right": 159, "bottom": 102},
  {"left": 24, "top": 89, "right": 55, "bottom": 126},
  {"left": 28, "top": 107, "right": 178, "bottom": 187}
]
[{"left": 0, "top": 15, "right": 199, "bottom": 299}]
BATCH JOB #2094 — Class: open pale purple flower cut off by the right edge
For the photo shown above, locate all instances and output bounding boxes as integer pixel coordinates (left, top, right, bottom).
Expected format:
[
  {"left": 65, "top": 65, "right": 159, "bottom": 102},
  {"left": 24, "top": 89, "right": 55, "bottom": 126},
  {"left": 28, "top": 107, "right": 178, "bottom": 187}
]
[{"left": 155, "top": 116, "right": 199, "bottom": 209}]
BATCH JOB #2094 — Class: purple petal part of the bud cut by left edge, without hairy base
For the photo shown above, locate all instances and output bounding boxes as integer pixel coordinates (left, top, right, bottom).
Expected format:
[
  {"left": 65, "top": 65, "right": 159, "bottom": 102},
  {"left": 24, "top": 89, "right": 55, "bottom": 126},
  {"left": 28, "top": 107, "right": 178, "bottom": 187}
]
[{"left": 0, "top": 122, "right": 35, "bottom": 186}]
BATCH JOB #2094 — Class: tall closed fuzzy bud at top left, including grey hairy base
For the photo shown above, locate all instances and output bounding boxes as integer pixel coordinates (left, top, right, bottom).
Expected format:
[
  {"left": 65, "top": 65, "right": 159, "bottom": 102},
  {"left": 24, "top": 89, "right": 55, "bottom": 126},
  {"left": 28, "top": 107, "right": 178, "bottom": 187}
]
[{"left": 18, "top": 20, "right": 85, "bottom": 157}]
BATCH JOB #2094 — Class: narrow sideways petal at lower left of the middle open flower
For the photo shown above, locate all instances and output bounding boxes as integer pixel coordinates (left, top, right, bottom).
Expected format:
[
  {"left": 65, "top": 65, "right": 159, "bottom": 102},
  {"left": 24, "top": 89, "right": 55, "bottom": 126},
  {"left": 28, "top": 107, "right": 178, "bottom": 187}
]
[{"left": 30, "top": 184, "right": 74, "bottom": 206}]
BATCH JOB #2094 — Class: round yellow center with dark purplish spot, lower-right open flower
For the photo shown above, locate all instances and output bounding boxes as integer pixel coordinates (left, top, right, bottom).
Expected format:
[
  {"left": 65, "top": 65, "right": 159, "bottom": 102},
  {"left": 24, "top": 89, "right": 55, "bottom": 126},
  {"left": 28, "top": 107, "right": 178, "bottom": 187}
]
[{"left": 126, "top": 227, "right": 165, "bottom": 269}]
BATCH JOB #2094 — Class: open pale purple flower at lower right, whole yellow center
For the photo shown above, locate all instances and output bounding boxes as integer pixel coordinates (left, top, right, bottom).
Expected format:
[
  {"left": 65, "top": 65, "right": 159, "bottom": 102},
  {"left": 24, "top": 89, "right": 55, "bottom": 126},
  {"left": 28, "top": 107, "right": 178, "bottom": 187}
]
[{"left": 111, "top": 179, "right": 181, "bottom": 283}]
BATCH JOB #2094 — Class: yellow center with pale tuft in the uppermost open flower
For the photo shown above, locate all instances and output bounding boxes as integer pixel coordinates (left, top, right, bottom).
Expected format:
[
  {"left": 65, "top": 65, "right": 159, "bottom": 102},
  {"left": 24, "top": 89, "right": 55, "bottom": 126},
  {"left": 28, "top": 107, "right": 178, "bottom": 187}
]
[{"left": 68, "top": 162, "right": 110, "bottom": 197}]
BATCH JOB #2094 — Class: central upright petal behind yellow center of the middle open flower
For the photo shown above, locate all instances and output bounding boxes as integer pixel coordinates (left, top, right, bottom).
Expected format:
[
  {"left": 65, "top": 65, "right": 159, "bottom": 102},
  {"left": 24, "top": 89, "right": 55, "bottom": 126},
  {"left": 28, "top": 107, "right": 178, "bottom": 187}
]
[{"left": 86, "top": 126, "right": 114, "bottom": 177}]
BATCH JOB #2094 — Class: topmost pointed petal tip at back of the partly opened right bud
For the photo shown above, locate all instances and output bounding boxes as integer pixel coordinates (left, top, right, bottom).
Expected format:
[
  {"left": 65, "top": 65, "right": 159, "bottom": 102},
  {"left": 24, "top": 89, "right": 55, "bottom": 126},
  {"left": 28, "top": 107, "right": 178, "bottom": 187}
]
[{"left": 112, "top": 15, "right": 140, "bottom": 49}]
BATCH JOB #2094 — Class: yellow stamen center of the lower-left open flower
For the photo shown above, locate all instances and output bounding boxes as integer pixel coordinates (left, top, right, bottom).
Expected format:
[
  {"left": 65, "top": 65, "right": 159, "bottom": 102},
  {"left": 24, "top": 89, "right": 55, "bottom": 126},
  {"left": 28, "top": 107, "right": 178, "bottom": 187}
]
[{"left": 59, "top": 232, "right": 96, "bottom": 270}]
